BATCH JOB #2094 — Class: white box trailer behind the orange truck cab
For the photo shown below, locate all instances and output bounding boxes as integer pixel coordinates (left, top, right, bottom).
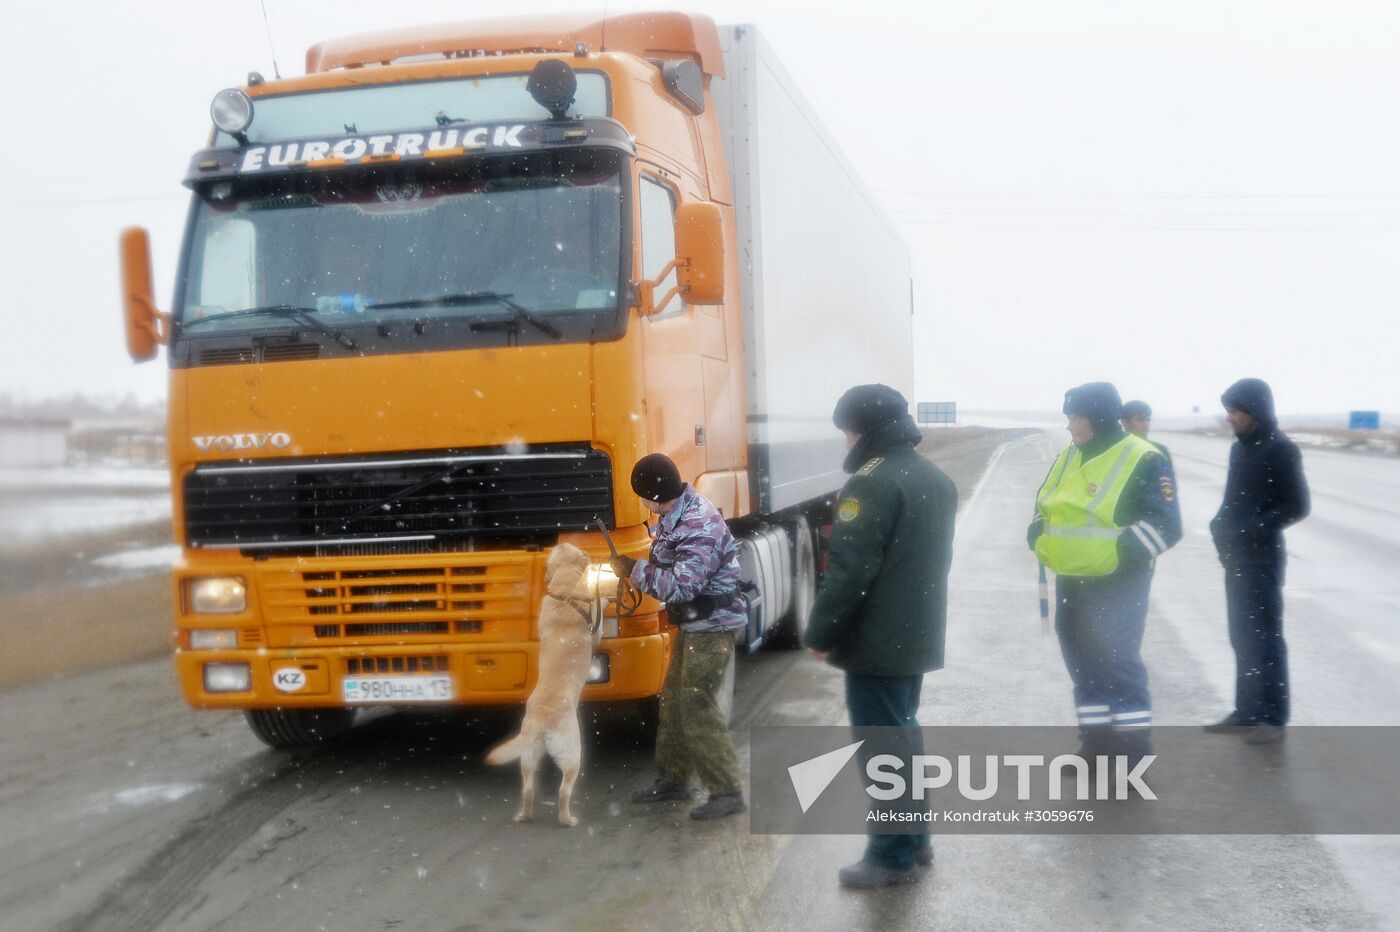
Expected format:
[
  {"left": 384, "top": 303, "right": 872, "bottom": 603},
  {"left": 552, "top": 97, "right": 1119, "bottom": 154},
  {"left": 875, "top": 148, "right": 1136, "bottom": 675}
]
[{"left": 710, "top": 25, "right": 914, "bottom": 515}]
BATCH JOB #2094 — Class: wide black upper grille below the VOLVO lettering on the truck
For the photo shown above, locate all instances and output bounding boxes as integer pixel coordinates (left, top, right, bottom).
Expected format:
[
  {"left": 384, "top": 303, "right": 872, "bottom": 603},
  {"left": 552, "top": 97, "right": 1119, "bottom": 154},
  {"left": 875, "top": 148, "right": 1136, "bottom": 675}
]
[{"left": 183, "top": 444, "right": 612, "bottom": 551}]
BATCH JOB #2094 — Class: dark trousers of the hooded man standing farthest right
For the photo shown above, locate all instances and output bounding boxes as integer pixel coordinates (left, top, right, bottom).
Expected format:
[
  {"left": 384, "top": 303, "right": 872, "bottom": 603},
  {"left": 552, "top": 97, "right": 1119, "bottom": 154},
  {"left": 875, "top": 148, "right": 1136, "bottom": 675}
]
[{"left": 1225, "top": 564, "right": 1288, "bottom": 725}]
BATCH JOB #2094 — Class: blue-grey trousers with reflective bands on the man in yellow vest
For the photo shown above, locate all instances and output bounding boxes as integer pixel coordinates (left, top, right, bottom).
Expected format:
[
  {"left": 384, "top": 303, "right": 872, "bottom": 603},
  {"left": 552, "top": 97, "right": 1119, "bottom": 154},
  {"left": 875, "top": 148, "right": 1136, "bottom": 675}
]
[{"left": 1054, "top": 567, "right": 1152, "bottom": 754}]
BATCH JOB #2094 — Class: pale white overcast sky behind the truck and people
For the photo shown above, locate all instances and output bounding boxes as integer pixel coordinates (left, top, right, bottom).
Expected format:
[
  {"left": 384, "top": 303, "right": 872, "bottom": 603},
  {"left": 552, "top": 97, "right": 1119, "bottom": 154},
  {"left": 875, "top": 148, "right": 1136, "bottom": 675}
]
[{"left": 0, "top": 0, "right": 1400, "bottom": 417}]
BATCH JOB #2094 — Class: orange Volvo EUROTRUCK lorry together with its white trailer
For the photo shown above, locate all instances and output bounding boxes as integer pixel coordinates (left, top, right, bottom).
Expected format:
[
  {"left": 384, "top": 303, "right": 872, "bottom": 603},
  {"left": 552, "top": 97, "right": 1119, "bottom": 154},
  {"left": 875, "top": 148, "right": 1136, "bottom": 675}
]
[{"left": 120, "top": 13, "right": 911, "bottom": 746}]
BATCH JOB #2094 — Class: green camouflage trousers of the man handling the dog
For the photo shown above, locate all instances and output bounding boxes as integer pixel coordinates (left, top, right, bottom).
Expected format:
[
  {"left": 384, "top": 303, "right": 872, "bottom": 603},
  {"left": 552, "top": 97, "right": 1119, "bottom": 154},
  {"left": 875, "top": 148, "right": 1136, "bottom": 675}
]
[{"left": 657, "top": 631, "right": 742, "bottom": 796}]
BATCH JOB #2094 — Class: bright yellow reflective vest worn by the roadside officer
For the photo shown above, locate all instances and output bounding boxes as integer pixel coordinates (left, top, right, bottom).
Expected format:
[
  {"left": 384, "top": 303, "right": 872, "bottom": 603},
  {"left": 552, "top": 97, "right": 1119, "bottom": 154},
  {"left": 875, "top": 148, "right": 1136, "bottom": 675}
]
[{"left": 1036, "top": 434, "right": 1156, "bottom": 577}]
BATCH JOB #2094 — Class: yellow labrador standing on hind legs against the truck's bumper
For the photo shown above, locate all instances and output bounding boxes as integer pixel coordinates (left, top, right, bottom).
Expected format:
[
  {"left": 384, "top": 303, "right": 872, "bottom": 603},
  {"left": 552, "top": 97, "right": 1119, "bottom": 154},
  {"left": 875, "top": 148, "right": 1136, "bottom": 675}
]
[{"left": 486, "top": 543, "right": 594, "bottom": 827}]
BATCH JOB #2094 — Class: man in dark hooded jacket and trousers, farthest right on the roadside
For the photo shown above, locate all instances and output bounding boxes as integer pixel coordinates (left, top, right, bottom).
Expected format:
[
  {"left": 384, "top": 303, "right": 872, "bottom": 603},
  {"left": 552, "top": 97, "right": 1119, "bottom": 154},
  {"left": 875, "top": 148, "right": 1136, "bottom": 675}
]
[{"left": 1205, "top": 379, "right": 1310, "bottom": 744}]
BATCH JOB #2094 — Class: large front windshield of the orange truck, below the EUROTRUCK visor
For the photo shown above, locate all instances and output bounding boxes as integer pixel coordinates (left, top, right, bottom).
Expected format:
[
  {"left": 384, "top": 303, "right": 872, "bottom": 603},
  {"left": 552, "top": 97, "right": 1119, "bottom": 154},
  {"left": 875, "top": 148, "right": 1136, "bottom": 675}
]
[{"left": 179, "top": 150, "right": 623, "bottom": 351}]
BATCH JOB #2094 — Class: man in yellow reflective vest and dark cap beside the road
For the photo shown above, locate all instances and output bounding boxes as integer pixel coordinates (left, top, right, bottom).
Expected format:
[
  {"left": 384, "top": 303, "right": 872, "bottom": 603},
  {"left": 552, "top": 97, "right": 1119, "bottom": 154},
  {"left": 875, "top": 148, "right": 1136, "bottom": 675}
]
[{"left": 1026, "top": 382, "right": 1182, "bottom": 760}]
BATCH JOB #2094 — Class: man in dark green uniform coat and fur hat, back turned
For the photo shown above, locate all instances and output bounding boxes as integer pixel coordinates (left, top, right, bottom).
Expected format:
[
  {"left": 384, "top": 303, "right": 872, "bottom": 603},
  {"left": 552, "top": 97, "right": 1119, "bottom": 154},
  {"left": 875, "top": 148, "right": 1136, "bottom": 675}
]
[{"left": 804, "top": 385, "right": 958, "bottom": 887}]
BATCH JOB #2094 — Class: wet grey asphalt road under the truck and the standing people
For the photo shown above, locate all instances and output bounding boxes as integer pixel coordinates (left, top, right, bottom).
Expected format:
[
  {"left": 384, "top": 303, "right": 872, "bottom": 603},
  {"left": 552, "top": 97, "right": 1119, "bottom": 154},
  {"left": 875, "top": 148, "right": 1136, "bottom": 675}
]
[{"left": 0, "top": 434, "right": 1400, "bottom": 932}]
